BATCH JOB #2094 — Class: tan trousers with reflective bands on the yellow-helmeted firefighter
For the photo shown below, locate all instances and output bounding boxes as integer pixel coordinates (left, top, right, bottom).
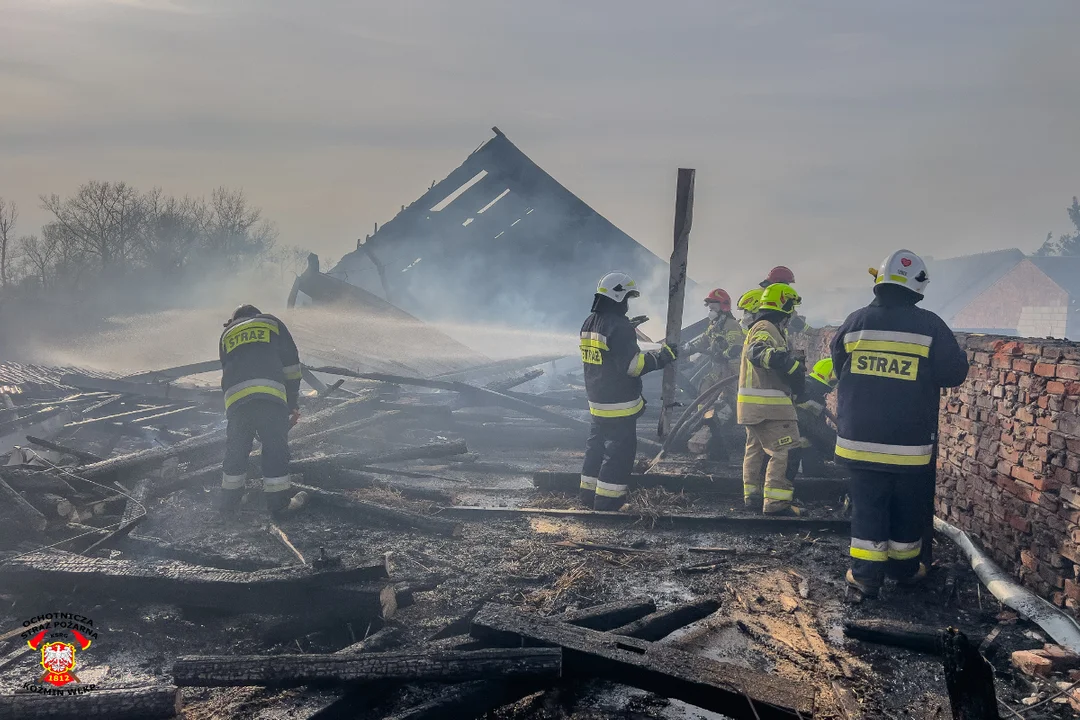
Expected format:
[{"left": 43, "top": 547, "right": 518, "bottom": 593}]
[{"left": 743, "top": 420, "right": 799, "bottom": 513}]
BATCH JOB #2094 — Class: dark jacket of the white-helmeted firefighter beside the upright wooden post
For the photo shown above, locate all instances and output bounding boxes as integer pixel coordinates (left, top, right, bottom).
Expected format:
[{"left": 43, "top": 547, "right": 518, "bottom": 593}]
[{"left": 581, "top": 303, "right": 671, "bottom": 418}]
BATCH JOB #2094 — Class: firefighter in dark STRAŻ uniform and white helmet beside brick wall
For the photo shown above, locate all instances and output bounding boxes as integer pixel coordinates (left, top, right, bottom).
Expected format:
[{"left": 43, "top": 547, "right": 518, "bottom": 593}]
[{"left": 832, "top": 249, "right": 968, "bottom": 597}]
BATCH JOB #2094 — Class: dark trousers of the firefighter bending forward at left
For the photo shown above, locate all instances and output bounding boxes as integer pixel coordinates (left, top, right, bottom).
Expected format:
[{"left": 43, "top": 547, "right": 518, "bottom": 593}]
[{"left": 221, "top": 399, "right": 292, "bottom": 512}]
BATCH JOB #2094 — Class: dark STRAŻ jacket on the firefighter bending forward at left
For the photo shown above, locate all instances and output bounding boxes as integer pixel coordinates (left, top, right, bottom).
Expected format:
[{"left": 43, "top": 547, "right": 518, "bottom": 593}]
[{"left": 218, "top": 314, "right": 300, "bottom": 412}]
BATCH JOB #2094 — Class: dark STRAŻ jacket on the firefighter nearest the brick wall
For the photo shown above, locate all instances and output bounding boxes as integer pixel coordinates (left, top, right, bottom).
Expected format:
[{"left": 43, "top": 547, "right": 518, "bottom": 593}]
[{"left": 832, "top": 288, "right": 968, "bottom": 473}]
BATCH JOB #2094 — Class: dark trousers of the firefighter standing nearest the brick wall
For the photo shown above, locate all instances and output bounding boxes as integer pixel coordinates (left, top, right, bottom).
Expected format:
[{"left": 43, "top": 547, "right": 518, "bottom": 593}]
[{"left": 850, "top": 466, "right": 934, "bottom": 588}]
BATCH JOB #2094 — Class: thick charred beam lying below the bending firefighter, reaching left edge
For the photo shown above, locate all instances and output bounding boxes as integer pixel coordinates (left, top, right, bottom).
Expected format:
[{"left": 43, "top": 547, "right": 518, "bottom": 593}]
[{"left": 0, "top": 551, "right": 397, "bottom": 617}]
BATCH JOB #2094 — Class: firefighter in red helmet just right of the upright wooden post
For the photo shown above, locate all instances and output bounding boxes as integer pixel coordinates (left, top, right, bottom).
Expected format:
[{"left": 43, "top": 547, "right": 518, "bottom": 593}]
[{"left": 683, "top": 288, "right": 746, "bottom": 460}]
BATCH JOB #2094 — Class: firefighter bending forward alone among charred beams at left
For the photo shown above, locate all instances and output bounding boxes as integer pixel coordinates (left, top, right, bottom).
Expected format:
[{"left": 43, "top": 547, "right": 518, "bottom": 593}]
[{"left": 218, "top": 304, "right": 300, "bottom": 515}]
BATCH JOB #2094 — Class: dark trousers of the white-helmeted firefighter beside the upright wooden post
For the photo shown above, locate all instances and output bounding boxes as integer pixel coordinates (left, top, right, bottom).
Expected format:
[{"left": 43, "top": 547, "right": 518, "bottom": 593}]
[{"left": 581, "top": 416, "right": 637, "bottom": 510}]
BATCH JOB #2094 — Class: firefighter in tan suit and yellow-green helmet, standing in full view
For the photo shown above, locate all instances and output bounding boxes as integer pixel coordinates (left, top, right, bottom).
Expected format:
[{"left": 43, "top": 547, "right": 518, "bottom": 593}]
[{"left": 737, "top": 283, "right": 806, "bottom": 516}]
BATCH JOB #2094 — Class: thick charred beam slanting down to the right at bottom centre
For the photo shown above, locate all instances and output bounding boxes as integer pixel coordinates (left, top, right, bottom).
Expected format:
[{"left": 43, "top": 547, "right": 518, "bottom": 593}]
[{"left": 471, "top": 603, "right": 814, "bottom": 720}]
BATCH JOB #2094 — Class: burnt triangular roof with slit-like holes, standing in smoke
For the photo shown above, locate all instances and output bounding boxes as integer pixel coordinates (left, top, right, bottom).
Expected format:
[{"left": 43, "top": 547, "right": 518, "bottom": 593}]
[{"left": 330, "top": 128, "right": 699, "bottom": 330}]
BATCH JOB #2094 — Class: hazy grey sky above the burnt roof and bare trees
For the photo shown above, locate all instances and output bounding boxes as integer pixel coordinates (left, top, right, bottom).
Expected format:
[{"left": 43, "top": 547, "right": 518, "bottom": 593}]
[{"left": 0, "top": 0, "right": 1080, "bottom": 302}]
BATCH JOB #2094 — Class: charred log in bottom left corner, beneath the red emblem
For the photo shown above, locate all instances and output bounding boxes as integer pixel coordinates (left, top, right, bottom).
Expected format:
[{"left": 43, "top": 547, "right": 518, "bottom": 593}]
[{"left": 0, "top": 685, "right": 184, "bottom": 720}]
